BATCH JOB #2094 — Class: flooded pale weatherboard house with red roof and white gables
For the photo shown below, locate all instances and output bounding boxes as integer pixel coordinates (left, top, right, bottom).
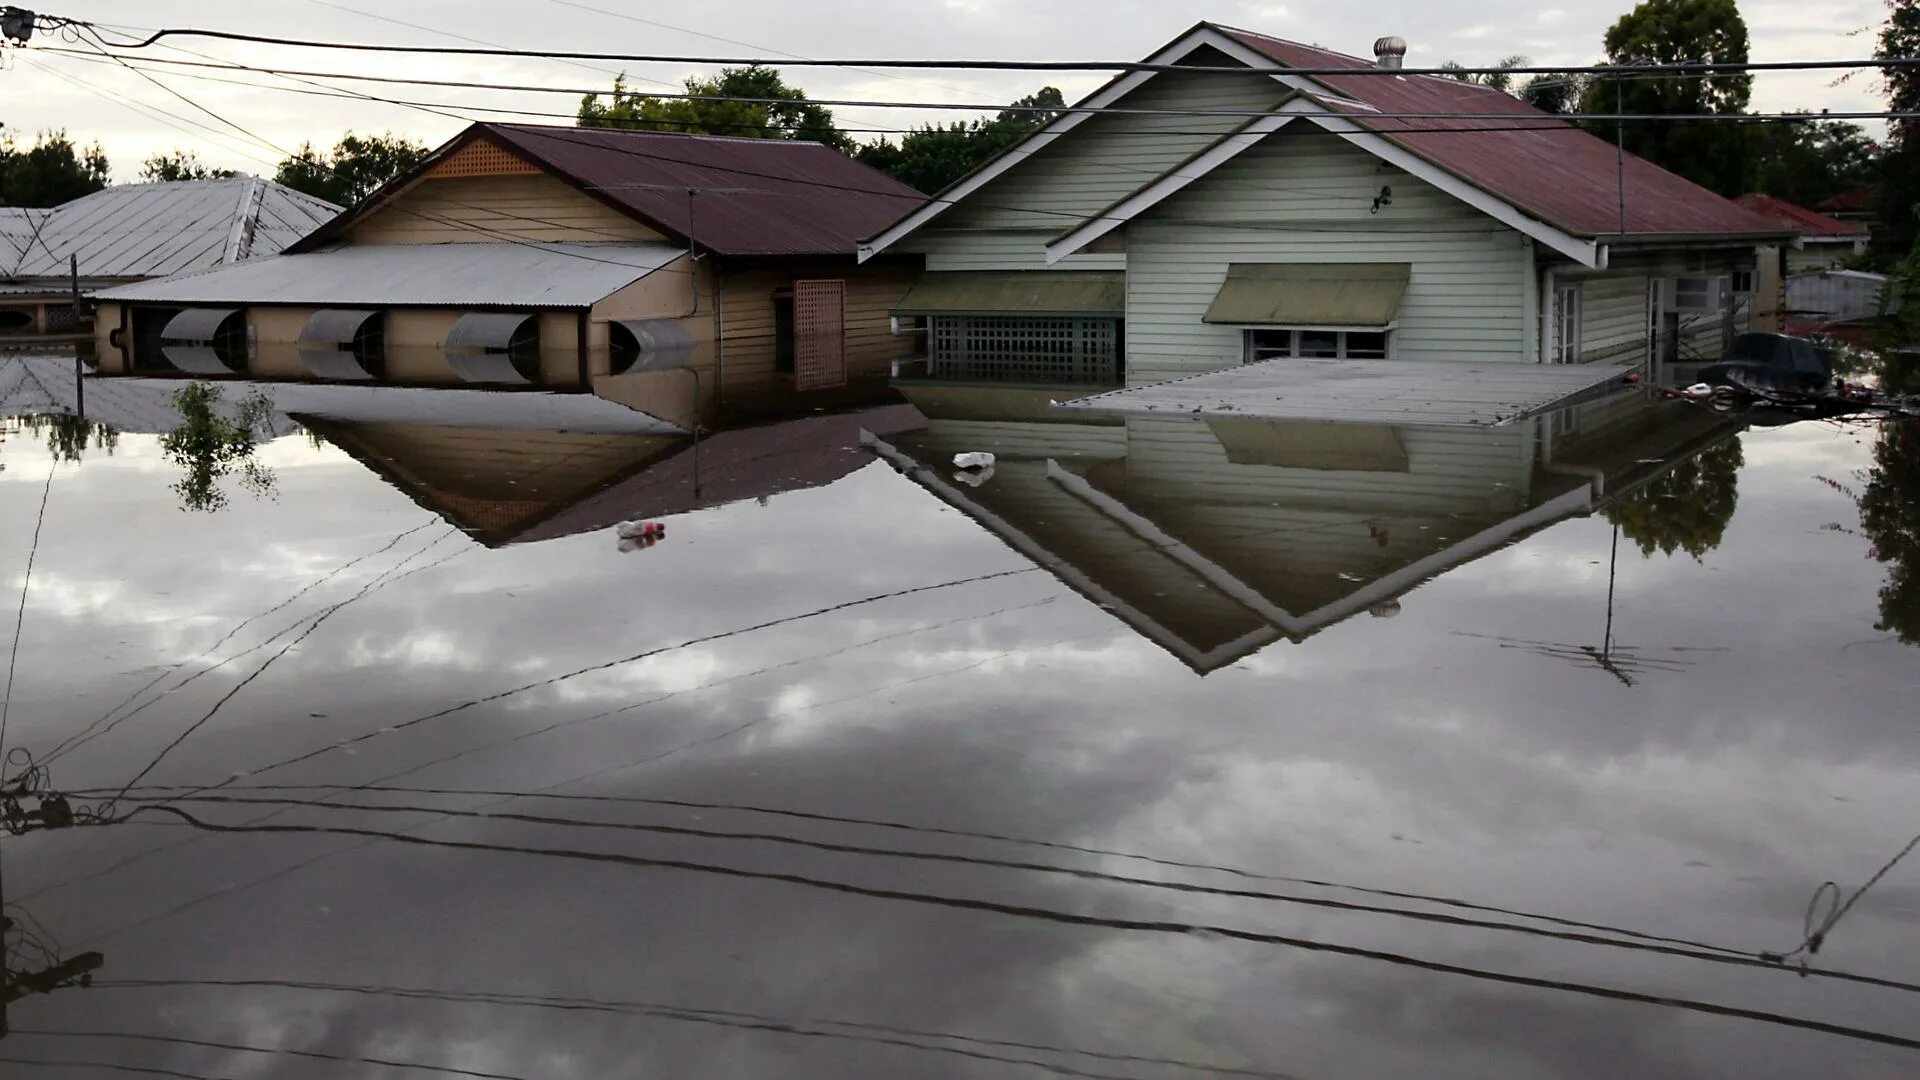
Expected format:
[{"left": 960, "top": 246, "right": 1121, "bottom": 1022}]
[{"left": 860, "top": 23, "right": 1786, "bottom": 386}]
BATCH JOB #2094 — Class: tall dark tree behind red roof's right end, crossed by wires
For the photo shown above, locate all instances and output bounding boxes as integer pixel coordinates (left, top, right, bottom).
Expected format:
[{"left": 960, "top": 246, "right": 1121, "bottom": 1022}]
[{"left": 1582, "top": 0, "right": 1755, "bottom": 196}]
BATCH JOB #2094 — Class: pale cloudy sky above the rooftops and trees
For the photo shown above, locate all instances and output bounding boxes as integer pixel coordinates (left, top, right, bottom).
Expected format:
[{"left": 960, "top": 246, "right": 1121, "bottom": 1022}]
[{"left": 0, "top": 0, "right": 1884, "bottom": 181}]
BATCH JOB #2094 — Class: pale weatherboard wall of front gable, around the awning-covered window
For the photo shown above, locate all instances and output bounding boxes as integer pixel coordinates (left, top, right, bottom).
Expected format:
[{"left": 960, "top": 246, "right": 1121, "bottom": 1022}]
[{"left": 1127, "top": 133, "right": 1532, "bottom": 384}]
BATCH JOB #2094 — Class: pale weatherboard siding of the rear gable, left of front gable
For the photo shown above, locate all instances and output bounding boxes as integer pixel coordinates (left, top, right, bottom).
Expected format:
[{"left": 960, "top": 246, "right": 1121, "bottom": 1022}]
[{"left": 900, "top": 71, "right": 1290, "bottom": 271}]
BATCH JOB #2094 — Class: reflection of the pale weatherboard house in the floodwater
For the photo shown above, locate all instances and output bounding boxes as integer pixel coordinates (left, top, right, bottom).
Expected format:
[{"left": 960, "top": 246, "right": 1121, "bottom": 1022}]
[{"left": 876, "top": 386, "right": 1734, "bottom": 673}]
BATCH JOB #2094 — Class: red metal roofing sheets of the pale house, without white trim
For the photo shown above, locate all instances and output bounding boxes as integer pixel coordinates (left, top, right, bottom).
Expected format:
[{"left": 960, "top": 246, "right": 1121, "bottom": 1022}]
[{"left": 1217, "top": 27, "right": 1782, "bottom": 236}]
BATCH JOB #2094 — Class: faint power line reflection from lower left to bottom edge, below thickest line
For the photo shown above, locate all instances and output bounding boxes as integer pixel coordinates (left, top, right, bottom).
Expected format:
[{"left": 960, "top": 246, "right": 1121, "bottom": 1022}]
[{"left": 82, "top": 978, "right": 1288, "bottom": 1080}]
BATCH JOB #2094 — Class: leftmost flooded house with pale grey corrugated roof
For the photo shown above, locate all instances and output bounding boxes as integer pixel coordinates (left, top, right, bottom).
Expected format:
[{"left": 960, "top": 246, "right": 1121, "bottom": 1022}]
[{"left": 0, "top": 177, "right": 340, "bottom": 344}]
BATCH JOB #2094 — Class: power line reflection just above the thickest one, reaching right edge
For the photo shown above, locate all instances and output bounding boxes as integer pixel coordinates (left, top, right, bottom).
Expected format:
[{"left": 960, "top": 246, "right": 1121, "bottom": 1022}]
[{"left": 101, "top": 776, "right": 1920, "bottom": 994}]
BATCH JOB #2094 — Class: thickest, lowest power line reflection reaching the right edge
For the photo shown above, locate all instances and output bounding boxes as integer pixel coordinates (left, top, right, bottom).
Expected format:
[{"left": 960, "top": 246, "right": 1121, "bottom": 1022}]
[{"left": 97, "top": 807, "right": 1920, "bottom": 1049}]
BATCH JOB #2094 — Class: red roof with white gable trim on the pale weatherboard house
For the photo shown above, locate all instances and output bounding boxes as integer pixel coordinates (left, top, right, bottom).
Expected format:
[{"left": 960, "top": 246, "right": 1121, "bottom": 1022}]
[{"left": 862, "top": 23, "right": 1784, "bottom": 261}]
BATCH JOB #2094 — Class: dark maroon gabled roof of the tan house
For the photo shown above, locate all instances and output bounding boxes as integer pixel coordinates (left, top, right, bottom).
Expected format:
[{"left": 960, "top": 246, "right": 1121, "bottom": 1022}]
[{"left": 298, "top": 123, "right": 925, "bottom": 256}]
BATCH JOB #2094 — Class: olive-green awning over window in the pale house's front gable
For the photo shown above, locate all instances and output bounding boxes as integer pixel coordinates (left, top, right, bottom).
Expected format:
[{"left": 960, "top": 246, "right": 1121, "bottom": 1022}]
[{"left": 1204, "top": 263, "right": 1413, "bottom": 327}]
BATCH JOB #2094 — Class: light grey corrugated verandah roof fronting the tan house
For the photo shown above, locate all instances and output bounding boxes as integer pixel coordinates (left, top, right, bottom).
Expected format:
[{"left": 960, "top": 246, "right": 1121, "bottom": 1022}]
[{"left": 98, "top": 244, "right": 685, "bottom": 307}]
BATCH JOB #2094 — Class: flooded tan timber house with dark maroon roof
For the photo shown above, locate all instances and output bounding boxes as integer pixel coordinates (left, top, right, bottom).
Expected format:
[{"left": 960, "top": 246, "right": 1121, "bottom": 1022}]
[{"left": 98, "top": 123, "right": 924, "bottom": 423}]
